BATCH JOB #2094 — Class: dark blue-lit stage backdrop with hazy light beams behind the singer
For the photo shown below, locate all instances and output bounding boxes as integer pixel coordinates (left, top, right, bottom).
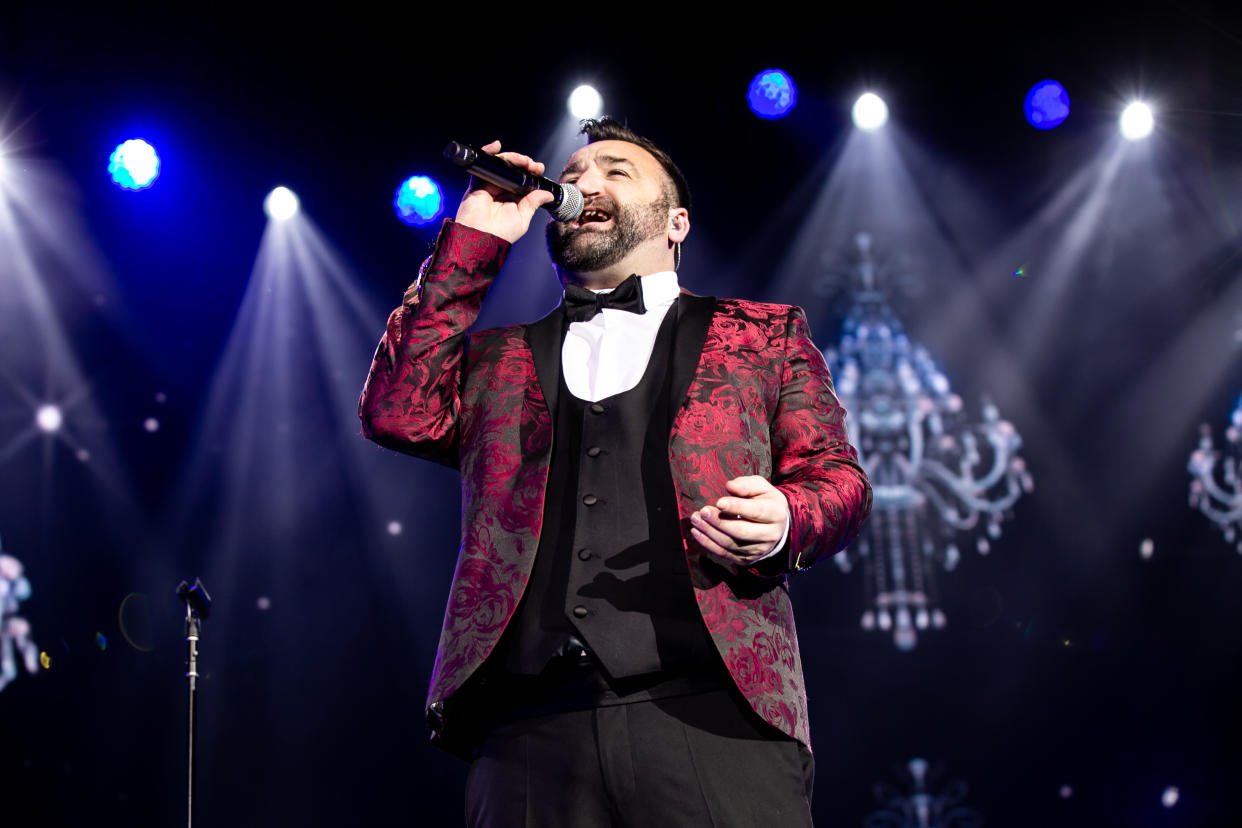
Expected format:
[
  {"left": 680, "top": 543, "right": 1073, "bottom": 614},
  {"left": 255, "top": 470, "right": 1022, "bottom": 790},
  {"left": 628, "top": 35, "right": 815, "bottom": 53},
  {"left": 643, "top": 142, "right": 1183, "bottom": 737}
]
[{"left": 0, "top": 4, "right": 1242, "bottom": 826}]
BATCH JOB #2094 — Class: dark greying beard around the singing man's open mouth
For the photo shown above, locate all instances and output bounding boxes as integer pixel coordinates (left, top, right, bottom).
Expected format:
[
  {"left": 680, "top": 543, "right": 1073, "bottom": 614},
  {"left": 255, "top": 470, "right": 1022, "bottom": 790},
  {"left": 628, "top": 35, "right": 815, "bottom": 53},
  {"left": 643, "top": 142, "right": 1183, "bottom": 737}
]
[{"left": 545, "top": 193, "right": 668, "bottom": 273}]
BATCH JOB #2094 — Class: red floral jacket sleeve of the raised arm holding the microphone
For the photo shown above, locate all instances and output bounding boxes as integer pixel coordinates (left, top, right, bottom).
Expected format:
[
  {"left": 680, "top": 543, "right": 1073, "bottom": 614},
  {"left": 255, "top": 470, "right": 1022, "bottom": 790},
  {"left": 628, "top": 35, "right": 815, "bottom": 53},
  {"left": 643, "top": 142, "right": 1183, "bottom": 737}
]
[{"left": 358, "top": 220, "right": 509, "bottom": 468}]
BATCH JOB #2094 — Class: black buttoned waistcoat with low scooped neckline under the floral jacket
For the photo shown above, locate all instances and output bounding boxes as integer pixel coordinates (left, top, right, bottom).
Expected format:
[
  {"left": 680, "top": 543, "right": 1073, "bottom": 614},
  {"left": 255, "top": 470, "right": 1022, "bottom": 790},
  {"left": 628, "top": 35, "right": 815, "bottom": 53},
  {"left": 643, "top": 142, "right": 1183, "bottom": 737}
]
[{"left": 504, "top": 305, "right": 714, "bottom": 678}]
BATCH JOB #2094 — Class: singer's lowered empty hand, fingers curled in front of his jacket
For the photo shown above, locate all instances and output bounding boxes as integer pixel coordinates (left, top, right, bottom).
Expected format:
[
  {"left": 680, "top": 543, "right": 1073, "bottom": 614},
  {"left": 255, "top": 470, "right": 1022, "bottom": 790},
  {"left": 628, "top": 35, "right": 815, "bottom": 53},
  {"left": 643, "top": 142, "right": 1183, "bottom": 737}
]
[{"left": 691, "top": 474, "right": 789, "bottom": 567}]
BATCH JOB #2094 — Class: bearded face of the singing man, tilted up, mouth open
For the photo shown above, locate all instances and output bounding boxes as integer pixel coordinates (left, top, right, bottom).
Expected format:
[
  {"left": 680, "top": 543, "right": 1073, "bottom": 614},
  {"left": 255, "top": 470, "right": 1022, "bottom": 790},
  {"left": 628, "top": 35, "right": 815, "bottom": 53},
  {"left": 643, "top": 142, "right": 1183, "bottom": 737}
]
[{"left": 546, "top": 140, "right": 672, "bottom": 273}]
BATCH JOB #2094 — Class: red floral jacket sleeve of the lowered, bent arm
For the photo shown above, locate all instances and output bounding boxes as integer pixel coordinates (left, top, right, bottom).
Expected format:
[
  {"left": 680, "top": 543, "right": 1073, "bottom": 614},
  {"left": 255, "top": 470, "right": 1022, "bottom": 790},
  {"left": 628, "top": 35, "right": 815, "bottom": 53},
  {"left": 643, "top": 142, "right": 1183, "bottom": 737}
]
[{"left": 754, "top": 308, "right": 871, "bottom": 575}]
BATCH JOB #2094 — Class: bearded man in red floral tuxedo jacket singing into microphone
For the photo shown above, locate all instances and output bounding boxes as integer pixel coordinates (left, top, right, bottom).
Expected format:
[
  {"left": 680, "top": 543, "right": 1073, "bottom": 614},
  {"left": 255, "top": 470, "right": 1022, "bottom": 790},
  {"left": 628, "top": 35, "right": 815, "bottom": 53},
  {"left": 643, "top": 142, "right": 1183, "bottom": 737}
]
[{"left": 359, "top": 119, "right": 871, "bottom": 828}]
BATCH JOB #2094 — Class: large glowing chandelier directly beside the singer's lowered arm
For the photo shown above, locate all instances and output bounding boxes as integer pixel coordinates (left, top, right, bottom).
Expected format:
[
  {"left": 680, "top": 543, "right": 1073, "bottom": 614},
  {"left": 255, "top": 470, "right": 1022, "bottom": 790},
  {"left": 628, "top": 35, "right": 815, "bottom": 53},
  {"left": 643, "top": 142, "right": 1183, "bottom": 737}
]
[{"left": 822, "top": 233, "right": 1033, "bottom": 650}]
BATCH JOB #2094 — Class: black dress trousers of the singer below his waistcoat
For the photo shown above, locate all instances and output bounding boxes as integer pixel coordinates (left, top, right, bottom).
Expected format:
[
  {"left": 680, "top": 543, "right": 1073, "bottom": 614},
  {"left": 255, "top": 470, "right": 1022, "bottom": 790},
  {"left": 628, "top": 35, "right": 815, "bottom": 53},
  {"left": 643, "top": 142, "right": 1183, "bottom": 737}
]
[{"left": 466, "top": 690, "right": 815, "bottom": 828}]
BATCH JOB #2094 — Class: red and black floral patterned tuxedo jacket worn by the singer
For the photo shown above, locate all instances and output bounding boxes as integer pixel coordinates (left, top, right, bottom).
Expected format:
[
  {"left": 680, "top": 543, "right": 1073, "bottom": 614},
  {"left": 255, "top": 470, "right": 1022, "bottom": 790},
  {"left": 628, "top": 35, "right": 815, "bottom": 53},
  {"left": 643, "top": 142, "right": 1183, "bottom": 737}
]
[{"left": 359, "top": 221, "right": 871, "bottom": 754}]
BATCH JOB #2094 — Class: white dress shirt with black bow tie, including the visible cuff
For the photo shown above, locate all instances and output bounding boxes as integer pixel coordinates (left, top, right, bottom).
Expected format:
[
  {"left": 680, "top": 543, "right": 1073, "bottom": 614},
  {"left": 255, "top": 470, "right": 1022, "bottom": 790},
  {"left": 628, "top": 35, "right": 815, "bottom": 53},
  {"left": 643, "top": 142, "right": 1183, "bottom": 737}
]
[{"left": 560, "top": 271, "right": 790, "bottom": 560}]
